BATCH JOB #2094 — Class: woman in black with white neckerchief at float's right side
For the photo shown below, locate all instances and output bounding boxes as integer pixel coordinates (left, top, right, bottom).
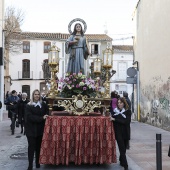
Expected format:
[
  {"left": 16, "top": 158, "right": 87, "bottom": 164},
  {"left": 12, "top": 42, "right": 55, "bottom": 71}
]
[{"left": 111, "top": 97, "right": 131, "bottom": 170}]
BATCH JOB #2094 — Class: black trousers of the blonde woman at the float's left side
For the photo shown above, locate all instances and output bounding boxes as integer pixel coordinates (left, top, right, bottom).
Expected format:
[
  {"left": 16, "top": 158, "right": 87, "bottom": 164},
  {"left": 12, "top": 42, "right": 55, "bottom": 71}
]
[{"left": 27, "top": 136, "right": 42, "bottom": 166}]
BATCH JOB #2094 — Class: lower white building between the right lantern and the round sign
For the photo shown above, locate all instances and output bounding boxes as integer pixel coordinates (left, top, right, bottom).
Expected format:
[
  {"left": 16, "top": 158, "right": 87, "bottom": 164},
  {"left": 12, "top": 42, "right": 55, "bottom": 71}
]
[{"left": 110, "top": 45, "right": 133, "bottom": 99}]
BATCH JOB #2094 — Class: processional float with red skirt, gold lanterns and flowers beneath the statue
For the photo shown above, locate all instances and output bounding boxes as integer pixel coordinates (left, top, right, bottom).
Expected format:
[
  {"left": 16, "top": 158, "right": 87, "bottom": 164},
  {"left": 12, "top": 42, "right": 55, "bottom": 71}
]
[{"left": 40, "top": 18, "right": 116, "bottom": 165}]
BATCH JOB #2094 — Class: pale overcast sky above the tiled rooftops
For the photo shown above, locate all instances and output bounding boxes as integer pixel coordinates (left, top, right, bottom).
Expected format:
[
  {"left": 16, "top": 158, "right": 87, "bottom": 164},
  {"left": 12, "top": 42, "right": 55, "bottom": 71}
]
[{"left": 5, "top": 0, "right": 138, "bottom": 43}]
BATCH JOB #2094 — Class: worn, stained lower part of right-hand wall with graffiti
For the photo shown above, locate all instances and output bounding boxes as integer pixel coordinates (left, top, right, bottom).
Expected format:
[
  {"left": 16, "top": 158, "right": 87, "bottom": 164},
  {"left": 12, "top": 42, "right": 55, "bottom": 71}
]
[{"left": 141, "top": 76, "right": 170, "bottom": 131}]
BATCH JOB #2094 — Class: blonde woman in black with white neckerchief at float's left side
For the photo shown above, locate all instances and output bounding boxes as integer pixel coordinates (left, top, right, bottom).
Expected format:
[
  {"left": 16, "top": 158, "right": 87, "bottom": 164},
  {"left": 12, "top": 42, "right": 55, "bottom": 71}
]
[{"left": 25, "top": 89, "right": 49, "bottom": 170}]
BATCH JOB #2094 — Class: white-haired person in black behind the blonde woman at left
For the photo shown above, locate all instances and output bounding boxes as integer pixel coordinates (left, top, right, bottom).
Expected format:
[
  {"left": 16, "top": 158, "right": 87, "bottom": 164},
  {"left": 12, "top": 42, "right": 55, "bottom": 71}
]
[{"left": 18, "top": 93, "right": 29, "bottom": 134}]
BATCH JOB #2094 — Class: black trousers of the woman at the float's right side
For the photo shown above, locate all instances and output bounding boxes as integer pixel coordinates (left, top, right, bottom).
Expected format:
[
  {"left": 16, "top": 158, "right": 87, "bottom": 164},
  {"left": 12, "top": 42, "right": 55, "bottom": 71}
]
[{"left": 117, "top": 139, "right": 128, "bottom": 168}]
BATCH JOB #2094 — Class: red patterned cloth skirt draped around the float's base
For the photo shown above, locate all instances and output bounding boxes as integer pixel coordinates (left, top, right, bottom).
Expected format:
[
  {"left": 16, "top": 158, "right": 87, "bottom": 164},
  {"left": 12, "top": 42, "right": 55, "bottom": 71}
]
[{"left": 40, "top": 116, "right": 116, "bottom": 165}]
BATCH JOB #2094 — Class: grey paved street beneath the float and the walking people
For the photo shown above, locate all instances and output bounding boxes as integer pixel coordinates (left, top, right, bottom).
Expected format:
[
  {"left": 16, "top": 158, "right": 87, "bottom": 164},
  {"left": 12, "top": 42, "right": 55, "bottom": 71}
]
[{"left": 0, "top": 113, "right": 170, "bottom": 170}]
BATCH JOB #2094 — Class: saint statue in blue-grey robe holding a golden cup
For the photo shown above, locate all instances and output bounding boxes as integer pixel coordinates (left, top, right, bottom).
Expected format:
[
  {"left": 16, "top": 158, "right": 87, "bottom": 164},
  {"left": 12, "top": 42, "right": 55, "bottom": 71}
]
[{"left": 65, "top": 23, "right": 90, "bottom": 74}]
